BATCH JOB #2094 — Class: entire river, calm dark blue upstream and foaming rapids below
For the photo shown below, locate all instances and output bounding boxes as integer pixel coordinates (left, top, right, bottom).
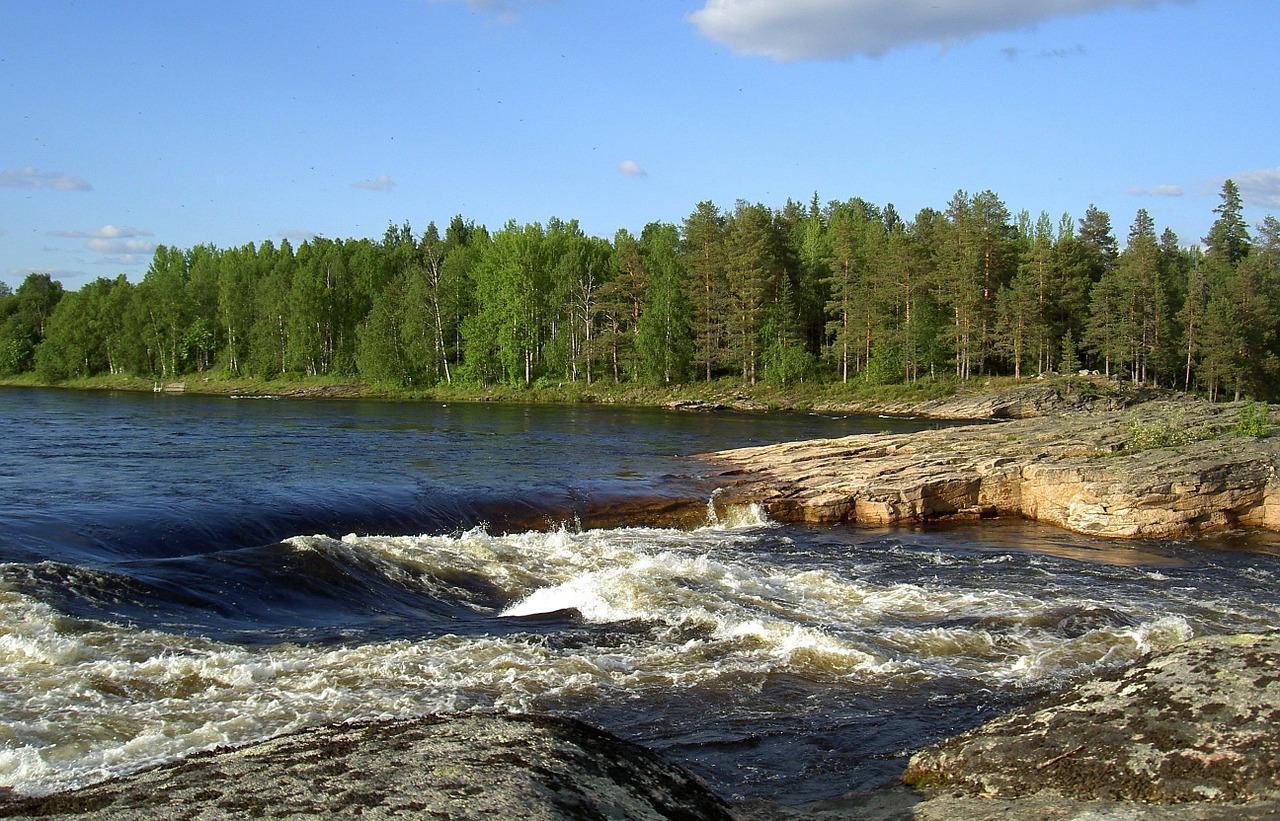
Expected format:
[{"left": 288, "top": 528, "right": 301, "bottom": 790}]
[{"left": 0, "top": 389, "right": 1280, "bottom": 802}]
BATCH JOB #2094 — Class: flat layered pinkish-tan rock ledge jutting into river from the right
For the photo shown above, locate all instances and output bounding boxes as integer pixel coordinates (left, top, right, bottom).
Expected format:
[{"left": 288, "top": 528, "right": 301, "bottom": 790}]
[{"left": 704, "top": 400, "right": 1280, "bottom": 538}]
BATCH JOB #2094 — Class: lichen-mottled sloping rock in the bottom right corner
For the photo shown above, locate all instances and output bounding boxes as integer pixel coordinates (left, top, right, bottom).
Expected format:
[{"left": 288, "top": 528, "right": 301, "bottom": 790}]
[{"left": 904, "top": 634, "right": 1280, "bottom": 817}]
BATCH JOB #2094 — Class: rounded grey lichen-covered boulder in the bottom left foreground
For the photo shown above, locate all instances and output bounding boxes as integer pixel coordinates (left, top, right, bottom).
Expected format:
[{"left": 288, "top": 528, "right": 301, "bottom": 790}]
[{"left": 0, "top": 716, "right": 731, "bottom": 821}]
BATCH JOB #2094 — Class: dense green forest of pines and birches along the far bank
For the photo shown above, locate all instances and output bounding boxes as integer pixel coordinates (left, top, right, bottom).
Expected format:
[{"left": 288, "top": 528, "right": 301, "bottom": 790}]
[{"left": 0, "top": 181, "right": 1280, "bottom": 400}]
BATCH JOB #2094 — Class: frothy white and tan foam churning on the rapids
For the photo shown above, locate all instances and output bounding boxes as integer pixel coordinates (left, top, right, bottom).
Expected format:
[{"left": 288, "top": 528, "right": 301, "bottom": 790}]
[{"left": 0, "top": 511, "right": 1280, "bottom": 794}]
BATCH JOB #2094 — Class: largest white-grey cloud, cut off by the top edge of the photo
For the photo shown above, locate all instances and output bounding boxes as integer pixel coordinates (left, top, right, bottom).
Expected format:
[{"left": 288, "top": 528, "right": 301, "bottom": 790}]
[{"left": 689, "top": 0, "right": 1187, "bottom": 61}]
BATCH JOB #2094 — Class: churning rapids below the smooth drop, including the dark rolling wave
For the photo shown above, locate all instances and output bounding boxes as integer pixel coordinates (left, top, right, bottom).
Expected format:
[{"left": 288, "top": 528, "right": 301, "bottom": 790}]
[{"left": 0, "top": 510, "right": 1277, "bottom": 793}]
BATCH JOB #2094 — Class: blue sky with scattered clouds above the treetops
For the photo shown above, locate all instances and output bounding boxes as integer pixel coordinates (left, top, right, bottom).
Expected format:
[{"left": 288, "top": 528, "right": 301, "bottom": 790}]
[{"left": 0, "top": 0, "right": 1280, "bottom": 289}]
